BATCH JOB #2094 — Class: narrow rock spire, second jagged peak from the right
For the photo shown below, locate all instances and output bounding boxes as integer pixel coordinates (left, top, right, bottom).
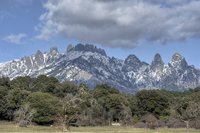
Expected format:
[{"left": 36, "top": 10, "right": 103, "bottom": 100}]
[{"left": 151, "top": 53, "right": 164, "bottom": 70}]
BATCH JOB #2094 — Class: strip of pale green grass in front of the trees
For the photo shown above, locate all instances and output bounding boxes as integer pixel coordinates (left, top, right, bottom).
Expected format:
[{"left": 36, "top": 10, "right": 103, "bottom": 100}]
[{"left": 0, "top": 122, "right": 200, "bottom": 133}]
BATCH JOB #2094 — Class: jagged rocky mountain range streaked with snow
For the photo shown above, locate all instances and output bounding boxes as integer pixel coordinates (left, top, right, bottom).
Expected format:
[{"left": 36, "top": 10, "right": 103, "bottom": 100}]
[{"left": 0, "top": 44, "right": 200, "bottom": 93}]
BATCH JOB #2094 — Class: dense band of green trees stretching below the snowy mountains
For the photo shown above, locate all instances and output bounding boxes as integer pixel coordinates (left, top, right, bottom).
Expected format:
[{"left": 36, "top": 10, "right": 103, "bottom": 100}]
[{"left": 0, "top": 75, "right": 200, "bottom": 130}]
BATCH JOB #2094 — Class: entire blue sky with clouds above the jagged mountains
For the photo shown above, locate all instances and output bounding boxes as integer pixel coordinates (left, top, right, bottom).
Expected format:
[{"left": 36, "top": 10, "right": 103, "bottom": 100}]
[{"left": 0, "top": 0, "right": 200, "bottom": 68}]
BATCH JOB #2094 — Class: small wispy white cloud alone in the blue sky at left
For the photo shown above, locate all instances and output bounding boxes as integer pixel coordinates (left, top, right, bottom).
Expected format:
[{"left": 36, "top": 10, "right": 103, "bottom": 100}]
[{"left": 3, "top": 33, "right": 27, "bottom": 44}]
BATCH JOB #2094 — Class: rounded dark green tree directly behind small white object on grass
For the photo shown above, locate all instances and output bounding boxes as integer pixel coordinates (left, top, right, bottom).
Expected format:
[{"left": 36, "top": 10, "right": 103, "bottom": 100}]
[{"left": 93, "top": 84, "right": 131, "bottom": 123}]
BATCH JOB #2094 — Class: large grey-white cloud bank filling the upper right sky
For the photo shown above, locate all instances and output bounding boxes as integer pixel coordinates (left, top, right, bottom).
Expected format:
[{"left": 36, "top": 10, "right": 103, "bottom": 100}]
[{"left": 37, "top": 0, "right": 200, "bottom": 48}]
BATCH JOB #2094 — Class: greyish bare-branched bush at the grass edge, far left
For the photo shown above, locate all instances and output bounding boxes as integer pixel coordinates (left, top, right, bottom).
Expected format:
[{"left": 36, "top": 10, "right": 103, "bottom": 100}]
[{"left": 14, "top": 103, "right": 36, "bottom": 127}]
